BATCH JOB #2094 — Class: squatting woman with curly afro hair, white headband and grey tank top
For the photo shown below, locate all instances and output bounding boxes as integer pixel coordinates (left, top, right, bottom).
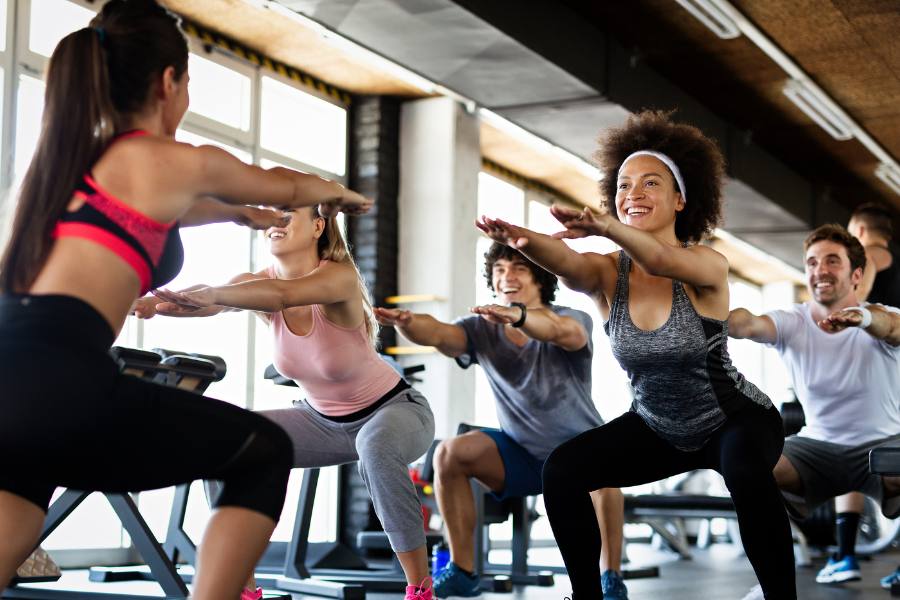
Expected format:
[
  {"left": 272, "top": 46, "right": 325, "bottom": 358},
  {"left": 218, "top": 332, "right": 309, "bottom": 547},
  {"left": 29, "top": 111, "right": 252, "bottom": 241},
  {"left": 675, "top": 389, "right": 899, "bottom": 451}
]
[{"left": 480, "top": 112, "right": 797, "bottom": 600}]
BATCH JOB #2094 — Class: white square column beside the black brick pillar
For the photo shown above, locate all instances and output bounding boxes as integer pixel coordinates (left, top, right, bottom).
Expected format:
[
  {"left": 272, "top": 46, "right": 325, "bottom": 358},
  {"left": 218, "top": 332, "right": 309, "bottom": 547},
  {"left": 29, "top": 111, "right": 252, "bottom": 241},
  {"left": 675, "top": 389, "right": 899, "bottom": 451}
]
[{"left": 398, "top": 98, "right": 481, "bottom": 438}]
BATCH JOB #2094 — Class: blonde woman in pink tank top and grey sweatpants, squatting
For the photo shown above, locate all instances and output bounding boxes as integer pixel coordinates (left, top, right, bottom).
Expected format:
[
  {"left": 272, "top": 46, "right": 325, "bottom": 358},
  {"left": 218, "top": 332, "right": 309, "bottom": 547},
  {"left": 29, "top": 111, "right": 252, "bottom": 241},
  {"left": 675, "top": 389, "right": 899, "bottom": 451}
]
[{"left": 135, "top": 208, "right": 434, "bottom": 600}]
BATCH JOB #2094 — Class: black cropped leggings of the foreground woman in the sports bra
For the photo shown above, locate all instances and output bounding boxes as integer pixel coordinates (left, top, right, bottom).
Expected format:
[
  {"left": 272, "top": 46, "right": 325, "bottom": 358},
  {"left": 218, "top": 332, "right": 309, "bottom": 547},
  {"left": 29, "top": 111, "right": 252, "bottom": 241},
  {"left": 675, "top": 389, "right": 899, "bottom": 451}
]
[{"left": 0, "top": 296, "right": 293, "bottom": 520}]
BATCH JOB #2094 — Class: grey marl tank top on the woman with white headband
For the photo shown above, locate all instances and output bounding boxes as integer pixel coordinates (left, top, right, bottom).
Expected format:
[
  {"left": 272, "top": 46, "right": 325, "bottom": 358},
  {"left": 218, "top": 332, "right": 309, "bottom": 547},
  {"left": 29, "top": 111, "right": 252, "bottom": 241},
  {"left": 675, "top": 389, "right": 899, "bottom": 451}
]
[{"left": 604, "top": 251, "right": 774, "bottom": 451}]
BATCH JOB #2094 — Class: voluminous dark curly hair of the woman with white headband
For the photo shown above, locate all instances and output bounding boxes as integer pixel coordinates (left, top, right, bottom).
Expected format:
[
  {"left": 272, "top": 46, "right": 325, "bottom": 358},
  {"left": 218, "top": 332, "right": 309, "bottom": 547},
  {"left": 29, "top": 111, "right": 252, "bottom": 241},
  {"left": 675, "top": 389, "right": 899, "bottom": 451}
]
[{"left": 594, "top": 110, "right": 725, "bottom": 243}]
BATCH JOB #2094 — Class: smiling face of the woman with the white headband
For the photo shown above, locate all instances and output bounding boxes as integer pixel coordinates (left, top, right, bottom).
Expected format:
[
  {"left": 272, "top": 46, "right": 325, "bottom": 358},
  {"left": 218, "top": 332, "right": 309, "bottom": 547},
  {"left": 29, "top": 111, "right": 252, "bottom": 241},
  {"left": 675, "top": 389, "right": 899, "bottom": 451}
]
[{"left": 616, "top": 155, "right": 684, "bottom": 231}]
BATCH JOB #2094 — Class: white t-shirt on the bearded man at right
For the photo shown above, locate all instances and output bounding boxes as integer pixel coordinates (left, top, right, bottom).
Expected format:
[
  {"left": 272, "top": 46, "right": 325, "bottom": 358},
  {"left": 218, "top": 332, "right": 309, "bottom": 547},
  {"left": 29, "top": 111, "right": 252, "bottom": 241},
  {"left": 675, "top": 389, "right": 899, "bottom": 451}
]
[{"left": 768, "top": 304, "right": 900, "bottom": 446}]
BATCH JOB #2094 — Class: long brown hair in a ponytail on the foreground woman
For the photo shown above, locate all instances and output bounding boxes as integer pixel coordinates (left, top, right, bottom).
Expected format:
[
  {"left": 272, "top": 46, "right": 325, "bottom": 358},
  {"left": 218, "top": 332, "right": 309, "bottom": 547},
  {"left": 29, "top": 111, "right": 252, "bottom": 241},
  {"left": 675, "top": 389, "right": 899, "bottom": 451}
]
[{"left": 0, "top": 0, "right": 188, "bottom": 292}]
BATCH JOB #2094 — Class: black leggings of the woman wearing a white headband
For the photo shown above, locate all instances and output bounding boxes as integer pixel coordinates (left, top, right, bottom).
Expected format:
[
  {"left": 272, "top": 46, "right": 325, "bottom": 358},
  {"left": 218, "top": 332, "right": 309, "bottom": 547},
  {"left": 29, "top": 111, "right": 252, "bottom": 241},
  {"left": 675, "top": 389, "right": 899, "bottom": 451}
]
[{"left": 544, "top": 406, "right": 797, "bottom": 600}]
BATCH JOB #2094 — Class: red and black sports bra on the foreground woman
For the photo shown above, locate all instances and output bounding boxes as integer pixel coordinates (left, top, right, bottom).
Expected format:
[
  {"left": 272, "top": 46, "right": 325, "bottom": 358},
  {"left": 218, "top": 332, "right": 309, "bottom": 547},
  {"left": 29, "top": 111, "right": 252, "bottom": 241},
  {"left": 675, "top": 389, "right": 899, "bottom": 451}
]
[{"left": 53, "top": 131, "right": 184, "bottom": 295}]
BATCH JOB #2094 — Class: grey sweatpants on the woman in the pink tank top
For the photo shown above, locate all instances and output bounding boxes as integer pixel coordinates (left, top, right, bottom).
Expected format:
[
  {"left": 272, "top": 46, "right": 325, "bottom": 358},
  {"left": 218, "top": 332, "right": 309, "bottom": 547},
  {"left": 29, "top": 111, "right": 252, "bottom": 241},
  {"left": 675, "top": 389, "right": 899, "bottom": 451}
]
[{"left": 260, "top": 389, "right": 434, "bottom": 552}]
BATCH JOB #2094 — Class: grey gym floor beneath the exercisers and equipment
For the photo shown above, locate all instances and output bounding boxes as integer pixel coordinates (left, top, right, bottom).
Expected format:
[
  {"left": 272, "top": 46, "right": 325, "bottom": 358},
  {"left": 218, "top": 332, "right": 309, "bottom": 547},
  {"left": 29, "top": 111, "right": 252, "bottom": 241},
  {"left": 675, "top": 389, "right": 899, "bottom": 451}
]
[{"left": 10, "top": 544, "right": 900, "bottom": 600}]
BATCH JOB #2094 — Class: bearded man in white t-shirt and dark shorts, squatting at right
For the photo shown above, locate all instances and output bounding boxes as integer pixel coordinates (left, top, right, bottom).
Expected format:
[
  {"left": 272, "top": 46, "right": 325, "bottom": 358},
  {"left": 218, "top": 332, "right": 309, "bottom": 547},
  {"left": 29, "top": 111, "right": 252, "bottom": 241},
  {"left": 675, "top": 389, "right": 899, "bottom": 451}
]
[{"left": 728, "top": 225, "right": 900, "bottom": 583}]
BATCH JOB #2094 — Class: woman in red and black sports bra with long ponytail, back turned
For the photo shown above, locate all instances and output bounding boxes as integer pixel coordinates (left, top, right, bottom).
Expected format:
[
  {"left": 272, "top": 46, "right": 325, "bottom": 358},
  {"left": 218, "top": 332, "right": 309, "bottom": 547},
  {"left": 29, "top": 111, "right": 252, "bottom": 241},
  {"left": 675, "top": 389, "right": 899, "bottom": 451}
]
[{"left": 0, "top": 0, "right": 370, "bottom": 600}]
